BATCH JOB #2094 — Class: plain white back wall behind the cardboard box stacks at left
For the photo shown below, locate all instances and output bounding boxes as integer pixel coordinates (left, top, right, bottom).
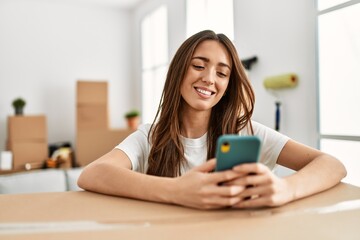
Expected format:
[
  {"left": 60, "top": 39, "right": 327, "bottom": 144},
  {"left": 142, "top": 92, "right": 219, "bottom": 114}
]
[{"left": 0, "top": 0, "right": 136, "bottom": 150}]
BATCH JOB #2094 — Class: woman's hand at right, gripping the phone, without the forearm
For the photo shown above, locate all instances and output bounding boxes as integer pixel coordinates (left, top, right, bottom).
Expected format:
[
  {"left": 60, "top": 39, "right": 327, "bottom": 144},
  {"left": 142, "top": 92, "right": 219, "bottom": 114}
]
[{"left": 224, "top": 163, "right": 294, "bottom": 208}]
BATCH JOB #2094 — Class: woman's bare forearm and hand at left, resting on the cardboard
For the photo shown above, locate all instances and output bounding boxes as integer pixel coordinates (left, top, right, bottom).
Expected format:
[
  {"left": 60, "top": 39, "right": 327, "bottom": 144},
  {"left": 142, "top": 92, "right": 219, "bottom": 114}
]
[{"left": 78, "top": 158, "right": 248, "bottom": 209}]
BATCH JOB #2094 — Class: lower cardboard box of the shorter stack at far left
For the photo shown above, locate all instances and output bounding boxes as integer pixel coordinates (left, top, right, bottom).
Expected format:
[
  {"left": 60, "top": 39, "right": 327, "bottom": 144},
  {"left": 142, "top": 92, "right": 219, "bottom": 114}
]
[{"left": 8, "top": 140, "right": 49, "bottom": 170}]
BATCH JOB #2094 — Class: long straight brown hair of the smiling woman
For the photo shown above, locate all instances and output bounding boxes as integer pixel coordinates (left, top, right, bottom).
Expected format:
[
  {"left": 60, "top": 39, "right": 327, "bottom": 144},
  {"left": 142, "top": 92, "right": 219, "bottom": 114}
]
[{"left": 147, "top": 30, "right": 255, "bottom": 177}]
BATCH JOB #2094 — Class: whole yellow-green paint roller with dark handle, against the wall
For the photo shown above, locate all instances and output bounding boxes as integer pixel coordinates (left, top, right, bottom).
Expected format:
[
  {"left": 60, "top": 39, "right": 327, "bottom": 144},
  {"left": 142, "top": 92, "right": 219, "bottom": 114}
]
[{"left": 264, "top": 73, "right": 299, "bottom": 131}]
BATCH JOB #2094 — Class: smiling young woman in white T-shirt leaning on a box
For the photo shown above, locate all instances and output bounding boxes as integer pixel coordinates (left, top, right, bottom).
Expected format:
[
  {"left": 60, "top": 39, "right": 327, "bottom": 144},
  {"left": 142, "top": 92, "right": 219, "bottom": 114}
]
[{"left": 78, "top": 31, "right": 346, "bottom": 209}]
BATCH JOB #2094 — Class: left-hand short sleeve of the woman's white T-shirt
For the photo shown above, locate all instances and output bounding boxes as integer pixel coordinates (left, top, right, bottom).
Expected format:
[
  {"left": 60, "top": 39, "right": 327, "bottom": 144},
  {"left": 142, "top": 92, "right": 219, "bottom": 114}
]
[{"left": 115, "top": 124, "right": 150, "bottom": 173}]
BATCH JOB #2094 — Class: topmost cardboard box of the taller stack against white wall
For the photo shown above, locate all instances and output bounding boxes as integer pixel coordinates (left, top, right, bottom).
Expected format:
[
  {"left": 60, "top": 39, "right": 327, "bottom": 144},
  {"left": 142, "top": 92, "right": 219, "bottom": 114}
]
[{"left": 76, "top": 80, "right": 108, "bottom": 105}]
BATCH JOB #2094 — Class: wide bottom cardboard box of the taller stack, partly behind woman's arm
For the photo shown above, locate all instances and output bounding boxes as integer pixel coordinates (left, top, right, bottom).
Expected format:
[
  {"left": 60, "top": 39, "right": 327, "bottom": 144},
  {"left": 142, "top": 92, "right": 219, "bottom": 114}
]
[{"left": 76, "top": 129, "right": 133, "bottom": 166}]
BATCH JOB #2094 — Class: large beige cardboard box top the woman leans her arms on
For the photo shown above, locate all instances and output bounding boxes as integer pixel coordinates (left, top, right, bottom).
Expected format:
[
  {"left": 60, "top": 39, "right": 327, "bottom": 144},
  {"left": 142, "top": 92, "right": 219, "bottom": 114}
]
[{"left": 0, "top": 184, "right": 360, "bottom": 239}]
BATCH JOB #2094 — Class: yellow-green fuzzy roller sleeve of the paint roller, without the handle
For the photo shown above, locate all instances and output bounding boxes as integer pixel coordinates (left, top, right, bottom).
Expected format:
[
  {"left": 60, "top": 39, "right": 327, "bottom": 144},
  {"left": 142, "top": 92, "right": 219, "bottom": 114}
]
[{"left": 264, "top": 73, "right": 299, "bottom": 89}]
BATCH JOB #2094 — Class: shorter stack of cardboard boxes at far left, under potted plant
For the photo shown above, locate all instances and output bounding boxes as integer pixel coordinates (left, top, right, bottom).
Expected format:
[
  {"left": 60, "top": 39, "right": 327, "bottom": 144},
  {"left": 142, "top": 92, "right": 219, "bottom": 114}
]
[{"left": 7, "top": 115, "right": 48, "bottom": 170}]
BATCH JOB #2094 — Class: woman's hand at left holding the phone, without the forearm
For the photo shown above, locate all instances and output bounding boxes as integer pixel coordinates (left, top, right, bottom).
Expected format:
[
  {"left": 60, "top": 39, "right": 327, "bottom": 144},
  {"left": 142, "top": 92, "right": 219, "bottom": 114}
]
[{"left": 173, "top": 159, "right": 244, "bottom": 209}]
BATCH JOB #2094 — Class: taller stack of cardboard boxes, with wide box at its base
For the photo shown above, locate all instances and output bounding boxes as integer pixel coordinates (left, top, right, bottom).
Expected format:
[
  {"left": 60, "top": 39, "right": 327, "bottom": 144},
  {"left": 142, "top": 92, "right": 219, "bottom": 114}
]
[{"left": 76, "top": 81, "right": 132, "bottom": 166}]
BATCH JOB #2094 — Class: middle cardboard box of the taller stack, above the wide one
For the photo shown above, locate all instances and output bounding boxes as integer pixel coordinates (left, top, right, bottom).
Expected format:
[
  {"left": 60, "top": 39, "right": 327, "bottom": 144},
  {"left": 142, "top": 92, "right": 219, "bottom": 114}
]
[{"left": 76, "top": 104, "right": 109, "bottom": 131}]
